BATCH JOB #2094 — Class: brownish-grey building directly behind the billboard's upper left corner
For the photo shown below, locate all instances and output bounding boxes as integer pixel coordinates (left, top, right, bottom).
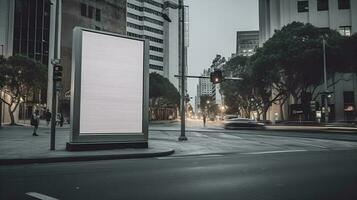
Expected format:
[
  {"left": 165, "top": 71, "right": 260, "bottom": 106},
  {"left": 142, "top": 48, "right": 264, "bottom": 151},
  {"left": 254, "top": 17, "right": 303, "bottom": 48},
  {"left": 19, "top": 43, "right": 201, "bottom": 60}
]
[{"left": 57, "top": 0, "right": 126, "bottom": 116}]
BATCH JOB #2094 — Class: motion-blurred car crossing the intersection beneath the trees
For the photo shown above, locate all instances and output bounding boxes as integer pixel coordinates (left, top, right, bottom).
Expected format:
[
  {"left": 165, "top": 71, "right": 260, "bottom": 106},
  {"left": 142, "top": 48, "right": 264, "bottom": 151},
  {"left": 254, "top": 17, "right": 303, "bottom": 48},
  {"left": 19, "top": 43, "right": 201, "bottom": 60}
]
[{"left": 224, "top": 118, "right": 265, "bottom": 130}]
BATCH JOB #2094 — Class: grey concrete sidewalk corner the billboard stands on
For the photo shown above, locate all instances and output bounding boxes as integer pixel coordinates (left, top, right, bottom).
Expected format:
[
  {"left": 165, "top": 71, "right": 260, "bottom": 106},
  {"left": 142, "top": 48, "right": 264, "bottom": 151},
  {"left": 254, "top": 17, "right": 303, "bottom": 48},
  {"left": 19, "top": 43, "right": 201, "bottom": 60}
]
[{"left": 0, "top": 126, "right": 174, "bottom": 165}]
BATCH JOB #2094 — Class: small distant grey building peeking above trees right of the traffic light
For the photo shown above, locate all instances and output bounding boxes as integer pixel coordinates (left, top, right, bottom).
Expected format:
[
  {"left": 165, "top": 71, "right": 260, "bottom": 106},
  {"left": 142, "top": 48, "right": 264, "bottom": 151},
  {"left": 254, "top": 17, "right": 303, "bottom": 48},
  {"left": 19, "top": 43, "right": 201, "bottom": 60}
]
[{"left": 235, "top": 31, "right": 259, "bottom": 56}]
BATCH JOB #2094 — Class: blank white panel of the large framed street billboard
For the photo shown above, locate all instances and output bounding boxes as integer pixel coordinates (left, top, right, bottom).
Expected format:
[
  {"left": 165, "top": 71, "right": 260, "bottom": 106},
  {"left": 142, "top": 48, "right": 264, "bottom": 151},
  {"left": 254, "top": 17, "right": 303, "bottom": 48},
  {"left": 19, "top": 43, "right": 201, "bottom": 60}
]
[{"left": 79, "top": 31, "right": 144, "bottom": 134}]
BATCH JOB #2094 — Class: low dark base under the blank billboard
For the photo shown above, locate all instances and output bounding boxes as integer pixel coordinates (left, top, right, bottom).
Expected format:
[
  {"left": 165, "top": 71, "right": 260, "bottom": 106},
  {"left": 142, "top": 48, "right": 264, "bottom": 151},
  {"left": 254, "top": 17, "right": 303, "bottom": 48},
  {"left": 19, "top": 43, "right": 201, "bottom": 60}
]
[{"left": 66, "top": 142, "right": 149, "bottom": 151}]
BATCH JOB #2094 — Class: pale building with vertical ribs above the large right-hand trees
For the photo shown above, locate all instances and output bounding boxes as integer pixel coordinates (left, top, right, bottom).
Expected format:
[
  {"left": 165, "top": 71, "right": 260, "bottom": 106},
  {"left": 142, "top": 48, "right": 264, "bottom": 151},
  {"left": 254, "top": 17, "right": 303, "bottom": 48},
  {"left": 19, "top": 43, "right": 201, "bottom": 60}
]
[{"left": 259, "top": 0, "right": 357, "bottom": 45}]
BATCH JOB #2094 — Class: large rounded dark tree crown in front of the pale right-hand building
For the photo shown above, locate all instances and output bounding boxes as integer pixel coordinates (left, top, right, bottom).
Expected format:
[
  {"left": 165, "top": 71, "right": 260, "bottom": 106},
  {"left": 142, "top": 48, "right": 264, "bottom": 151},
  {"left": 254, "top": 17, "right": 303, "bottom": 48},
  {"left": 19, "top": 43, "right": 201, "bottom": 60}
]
[{"left": 261, "top": 22, "right": 341, "bottom": 101}]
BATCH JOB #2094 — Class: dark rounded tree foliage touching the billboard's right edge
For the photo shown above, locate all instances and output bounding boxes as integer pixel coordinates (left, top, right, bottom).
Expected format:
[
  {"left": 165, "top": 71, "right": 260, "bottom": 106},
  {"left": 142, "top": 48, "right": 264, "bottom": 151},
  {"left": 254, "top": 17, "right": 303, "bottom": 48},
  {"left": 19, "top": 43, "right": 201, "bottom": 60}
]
[{"left": 149, "top": 73, "right": 180, "bottom": 107}]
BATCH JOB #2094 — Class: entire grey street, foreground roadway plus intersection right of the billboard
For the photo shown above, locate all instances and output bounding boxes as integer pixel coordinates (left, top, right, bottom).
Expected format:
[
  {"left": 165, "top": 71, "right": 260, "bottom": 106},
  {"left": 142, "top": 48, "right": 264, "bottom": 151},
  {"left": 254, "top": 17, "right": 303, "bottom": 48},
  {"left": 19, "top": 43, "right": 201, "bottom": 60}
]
[{"left": 0, "top": 121, "right": 357, "bottom": 200}]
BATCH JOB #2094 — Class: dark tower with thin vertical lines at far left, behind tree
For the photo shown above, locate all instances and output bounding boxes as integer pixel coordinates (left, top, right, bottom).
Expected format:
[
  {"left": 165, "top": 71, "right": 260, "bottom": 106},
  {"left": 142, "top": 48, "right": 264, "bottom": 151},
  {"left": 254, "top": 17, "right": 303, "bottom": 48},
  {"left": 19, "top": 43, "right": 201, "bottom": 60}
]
[{"left": 0, "top": 0, "right": 51, "bottom": 123}]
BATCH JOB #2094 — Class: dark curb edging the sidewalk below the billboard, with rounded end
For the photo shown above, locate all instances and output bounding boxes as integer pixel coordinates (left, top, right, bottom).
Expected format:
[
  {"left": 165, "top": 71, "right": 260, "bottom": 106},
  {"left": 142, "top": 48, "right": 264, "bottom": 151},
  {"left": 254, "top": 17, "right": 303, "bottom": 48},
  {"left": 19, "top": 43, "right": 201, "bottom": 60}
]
[{"left": 0, "top": 149, "right": 175, "bottom": 166}]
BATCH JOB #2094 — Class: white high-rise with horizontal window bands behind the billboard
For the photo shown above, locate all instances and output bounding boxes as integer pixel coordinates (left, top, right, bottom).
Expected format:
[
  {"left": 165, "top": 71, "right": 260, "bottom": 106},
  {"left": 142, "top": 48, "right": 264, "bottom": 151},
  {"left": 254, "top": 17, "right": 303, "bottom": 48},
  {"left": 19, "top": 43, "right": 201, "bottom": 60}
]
[{"left": 127, "top": 0, "right": 188, "bottom": 89}]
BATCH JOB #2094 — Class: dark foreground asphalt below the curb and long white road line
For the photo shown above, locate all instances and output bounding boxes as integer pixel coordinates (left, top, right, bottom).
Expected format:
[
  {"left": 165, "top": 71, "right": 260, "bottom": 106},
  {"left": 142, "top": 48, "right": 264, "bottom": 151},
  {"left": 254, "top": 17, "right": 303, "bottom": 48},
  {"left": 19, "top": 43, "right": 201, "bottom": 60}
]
[{"left": 0, "top": 150, "right": 357, "bottom": 200}]
